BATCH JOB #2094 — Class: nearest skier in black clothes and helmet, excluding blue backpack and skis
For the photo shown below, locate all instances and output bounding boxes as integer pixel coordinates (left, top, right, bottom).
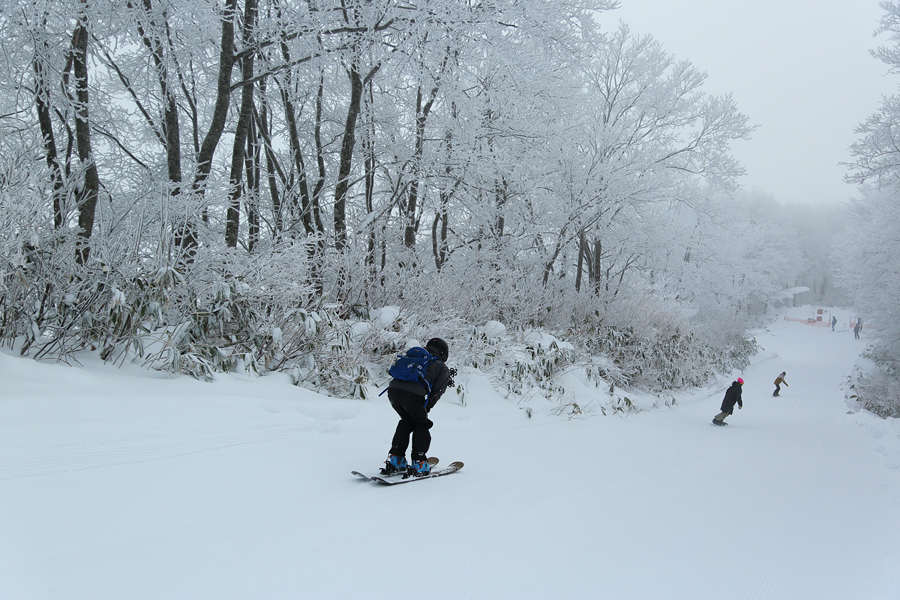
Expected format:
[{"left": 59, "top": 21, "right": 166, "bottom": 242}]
[{"left": 385, "top": 338, "right": 450, "bottom": 475}]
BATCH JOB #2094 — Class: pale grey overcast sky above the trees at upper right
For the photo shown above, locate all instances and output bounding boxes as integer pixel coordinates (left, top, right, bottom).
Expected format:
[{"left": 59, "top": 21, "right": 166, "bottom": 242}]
[{"left": 601, "top": 0, "right": 900, "bottom": 203}]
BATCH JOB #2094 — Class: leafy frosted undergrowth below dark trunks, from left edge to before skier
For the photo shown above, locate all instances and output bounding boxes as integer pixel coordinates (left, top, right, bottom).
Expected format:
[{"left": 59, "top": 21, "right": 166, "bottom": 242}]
[{"left": 0, "top": 225, "right": 327, "bottom": 379}]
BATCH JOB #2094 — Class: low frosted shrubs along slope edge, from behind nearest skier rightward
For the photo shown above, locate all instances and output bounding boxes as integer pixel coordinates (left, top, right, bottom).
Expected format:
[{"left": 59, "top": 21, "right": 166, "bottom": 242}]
[{"left": 354, "top": 278, "right": 756, "bottom": 414}]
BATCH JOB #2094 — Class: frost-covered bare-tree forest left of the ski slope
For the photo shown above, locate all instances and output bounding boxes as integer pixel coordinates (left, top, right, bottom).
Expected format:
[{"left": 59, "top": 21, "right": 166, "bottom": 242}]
[{"left": 0, "top": 0, "right": 813, "bottom": 398}]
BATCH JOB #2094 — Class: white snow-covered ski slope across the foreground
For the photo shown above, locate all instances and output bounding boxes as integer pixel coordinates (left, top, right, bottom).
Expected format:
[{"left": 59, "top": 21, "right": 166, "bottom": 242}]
[{"left": 0, "top": 309, "right": 900, "bottom": 600}]
